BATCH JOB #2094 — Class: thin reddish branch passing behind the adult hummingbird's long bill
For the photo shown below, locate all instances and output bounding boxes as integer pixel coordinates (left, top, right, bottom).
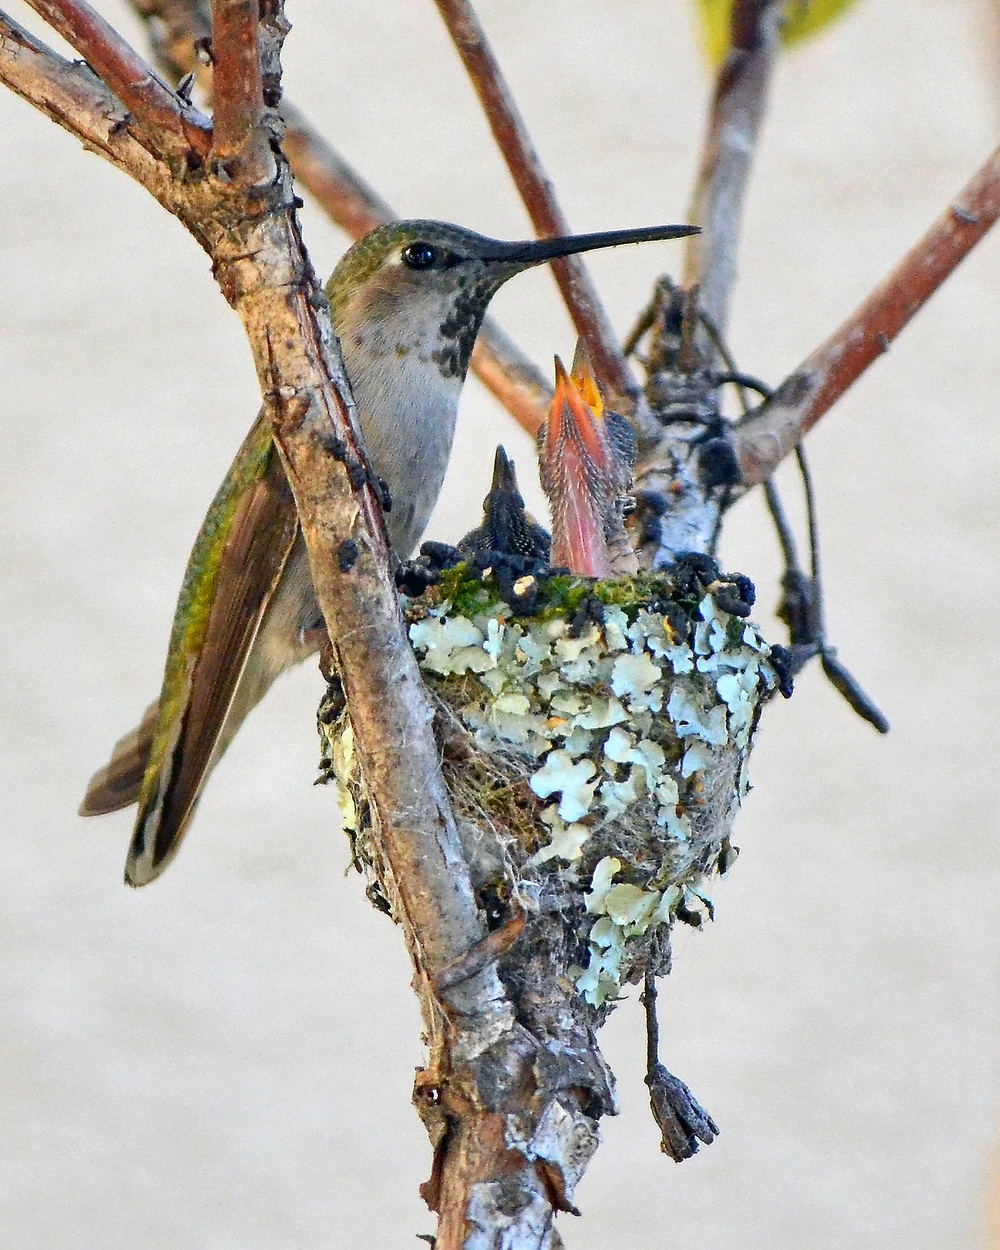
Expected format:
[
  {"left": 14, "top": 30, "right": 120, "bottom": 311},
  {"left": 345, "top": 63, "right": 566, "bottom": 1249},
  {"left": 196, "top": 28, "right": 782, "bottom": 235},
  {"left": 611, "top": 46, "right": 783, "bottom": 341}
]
[{"left": 435, "top": 0, "right": 640, "bottom": 406}]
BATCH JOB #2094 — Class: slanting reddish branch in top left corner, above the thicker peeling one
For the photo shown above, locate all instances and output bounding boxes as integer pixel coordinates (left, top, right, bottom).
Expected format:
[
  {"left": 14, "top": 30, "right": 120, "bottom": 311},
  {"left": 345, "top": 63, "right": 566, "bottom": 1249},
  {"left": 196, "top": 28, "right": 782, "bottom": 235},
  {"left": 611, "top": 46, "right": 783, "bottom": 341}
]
[{"left": 22, "top": 0, "right": 210, "bottom": 158}]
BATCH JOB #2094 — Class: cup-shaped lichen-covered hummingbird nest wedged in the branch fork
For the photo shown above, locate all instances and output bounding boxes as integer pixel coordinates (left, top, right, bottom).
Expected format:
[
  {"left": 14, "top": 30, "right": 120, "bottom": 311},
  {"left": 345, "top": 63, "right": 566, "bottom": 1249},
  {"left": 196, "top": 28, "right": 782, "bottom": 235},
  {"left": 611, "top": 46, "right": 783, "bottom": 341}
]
[{"left": 320, "top": 555, "right": 783, "bottom": 1014}]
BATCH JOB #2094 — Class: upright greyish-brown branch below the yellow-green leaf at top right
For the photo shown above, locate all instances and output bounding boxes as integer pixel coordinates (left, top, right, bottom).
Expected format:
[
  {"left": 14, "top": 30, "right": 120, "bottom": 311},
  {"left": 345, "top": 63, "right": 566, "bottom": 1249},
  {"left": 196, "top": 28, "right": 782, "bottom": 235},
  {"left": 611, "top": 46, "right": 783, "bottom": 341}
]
[{"left": 684, "top": 0, "right": 783, "bottom": 335}]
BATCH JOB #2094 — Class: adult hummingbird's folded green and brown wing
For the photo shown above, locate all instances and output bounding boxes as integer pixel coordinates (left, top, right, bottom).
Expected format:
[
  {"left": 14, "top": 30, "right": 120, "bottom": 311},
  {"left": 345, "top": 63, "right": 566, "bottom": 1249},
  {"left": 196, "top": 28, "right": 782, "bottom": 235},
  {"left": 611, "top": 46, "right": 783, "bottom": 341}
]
[{"left": 118, "top": 415, "right": 299, "bottom": 885}]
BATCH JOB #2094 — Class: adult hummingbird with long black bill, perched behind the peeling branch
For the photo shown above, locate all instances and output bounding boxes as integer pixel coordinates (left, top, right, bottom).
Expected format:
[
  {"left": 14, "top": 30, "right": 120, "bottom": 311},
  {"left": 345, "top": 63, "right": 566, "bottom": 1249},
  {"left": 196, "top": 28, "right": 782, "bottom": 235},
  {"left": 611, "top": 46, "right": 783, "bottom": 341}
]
[{"left": 80, "top": 220, "right": 698, "bottom": 886}]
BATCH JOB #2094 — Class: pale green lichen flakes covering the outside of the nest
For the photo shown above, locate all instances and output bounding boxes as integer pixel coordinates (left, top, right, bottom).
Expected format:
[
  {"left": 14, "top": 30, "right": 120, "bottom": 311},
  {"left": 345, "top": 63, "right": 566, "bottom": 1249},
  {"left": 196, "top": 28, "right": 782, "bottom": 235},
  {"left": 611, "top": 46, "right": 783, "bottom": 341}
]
[{"left": 400, "top": 574, "right": 776, "bottom": 1006}]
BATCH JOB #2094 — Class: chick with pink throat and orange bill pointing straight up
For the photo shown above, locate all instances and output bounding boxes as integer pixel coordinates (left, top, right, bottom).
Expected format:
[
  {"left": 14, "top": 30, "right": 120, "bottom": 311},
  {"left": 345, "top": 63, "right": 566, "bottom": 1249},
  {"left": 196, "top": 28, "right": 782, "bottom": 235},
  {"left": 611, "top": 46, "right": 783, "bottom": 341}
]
[{"left": 538, "top": 339, "right": 639, "bottom": 578}]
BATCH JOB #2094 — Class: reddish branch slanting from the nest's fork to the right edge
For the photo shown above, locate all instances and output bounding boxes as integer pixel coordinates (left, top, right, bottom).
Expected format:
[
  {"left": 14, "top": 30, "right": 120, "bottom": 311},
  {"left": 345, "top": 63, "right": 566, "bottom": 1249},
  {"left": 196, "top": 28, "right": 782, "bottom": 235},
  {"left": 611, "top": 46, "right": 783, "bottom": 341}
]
[{"left": 734, "top": 149, "right": 1000, "bottom": 486}]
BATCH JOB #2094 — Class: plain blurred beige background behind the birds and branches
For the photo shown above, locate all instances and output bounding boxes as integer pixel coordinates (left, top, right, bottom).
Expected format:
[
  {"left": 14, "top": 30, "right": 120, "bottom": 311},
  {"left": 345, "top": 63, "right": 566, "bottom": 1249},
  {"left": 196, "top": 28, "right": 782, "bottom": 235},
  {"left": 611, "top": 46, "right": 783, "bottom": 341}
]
[{"left": 0, "top": 0, "right": 1000, "bottom": 1250}]
